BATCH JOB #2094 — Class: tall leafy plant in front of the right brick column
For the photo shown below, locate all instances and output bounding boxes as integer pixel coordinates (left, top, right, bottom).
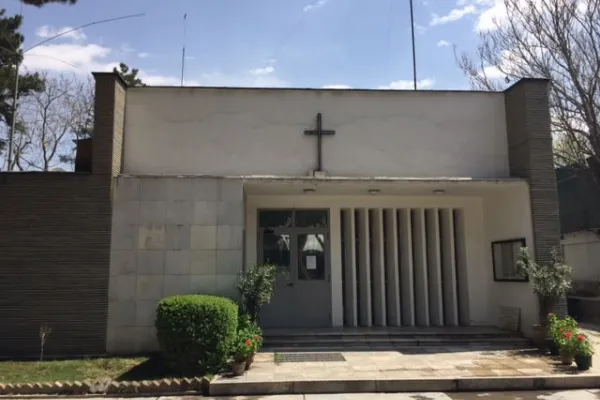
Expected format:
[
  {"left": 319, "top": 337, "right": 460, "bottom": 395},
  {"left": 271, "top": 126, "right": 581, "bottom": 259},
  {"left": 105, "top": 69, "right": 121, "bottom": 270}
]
[{"left": 517, "top": 247, "right": 572, "bottom": 349}]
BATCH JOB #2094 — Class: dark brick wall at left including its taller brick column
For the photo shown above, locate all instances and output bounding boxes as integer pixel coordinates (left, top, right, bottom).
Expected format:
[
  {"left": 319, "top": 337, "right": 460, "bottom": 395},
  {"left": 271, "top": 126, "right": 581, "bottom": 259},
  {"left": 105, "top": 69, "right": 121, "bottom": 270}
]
[{"left": 0, "top": 74, "right": 125, "bottom": 357}]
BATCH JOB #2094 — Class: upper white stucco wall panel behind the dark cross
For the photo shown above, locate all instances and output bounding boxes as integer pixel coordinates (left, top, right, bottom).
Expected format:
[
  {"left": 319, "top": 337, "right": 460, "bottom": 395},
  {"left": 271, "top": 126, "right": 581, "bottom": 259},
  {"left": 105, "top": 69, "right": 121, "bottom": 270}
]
[{"left": 124, "top": 87, "right": 509, "bottom": 177}]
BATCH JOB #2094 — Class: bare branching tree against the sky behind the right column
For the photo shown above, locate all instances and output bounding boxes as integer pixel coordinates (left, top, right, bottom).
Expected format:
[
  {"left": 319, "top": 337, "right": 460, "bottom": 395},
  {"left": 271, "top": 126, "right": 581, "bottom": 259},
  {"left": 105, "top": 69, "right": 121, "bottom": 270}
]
[{"left": 458, "top": 0, "right": 600, "bottom": 178}]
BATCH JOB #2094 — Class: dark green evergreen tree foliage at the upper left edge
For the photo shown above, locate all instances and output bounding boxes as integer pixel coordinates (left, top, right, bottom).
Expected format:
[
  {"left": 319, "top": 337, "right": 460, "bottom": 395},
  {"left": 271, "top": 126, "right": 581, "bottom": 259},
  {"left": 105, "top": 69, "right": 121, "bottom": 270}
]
[{"left": 0, "top": 9, "right": 44, "bottom": 159}]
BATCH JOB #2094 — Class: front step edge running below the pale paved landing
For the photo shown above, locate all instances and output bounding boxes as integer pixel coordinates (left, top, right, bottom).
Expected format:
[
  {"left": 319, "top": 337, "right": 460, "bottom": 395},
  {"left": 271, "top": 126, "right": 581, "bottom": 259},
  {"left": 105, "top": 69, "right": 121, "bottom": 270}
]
[{"left": 207, "top": 374, "right": 600, "bottom": 396}]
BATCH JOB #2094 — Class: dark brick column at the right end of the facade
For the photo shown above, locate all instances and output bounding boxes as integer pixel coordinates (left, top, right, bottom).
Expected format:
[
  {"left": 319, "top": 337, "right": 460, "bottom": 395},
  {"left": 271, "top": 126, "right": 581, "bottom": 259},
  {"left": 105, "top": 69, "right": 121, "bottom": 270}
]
[{"left": 504, "top": 79, "right": 560, "bottom": 262}]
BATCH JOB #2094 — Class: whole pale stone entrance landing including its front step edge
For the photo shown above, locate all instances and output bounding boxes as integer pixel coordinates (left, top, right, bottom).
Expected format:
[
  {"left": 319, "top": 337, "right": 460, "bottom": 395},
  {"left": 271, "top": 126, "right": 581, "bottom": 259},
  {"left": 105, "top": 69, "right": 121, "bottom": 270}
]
[{"left": 209, "top": 347, "right": 600, "bottom": 396}]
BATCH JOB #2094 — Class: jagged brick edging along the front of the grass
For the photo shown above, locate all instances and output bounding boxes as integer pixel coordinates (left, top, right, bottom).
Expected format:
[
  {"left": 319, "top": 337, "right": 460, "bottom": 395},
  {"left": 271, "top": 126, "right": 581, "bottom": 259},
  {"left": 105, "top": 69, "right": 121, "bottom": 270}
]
[{"left": 0, "top": 378, "right": 208, "bottom": 398}]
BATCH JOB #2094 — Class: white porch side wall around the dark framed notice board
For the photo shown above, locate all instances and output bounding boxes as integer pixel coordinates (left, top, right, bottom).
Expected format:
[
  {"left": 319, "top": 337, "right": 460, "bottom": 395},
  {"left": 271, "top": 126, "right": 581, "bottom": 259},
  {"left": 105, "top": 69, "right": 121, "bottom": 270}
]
[{"left": 483, "top": 185, "right": 538, "bottom": 335}]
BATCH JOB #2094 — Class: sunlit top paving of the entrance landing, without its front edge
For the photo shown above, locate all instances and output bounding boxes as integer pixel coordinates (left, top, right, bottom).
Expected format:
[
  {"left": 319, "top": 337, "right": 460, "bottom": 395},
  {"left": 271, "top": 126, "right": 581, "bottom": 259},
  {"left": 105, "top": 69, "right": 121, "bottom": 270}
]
[{"left": 220, "top": 347, "right": 600, "bottom": 382}]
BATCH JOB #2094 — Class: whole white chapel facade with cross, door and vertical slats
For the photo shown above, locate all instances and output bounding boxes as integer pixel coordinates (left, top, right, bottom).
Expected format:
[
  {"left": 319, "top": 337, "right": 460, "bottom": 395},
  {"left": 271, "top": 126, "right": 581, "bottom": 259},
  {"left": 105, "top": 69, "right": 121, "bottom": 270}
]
[{"left": 96, "top": 74, "right": 559, "bottom": 353}]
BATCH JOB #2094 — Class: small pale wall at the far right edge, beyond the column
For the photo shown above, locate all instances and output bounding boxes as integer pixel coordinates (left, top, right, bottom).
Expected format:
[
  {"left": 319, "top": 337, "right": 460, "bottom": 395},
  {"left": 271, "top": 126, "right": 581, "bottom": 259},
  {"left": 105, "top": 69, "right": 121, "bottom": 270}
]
[{"left": 561, "top": 232, "right": 600, "bottom": 282}]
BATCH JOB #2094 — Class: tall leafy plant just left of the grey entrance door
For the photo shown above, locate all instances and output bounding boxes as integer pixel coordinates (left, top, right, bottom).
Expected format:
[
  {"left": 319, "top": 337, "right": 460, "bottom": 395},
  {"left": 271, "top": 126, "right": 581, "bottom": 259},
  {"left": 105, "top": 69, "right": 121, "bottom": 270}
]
[{"left": 238, "top": 264, "right": 277, "bottom": 324}]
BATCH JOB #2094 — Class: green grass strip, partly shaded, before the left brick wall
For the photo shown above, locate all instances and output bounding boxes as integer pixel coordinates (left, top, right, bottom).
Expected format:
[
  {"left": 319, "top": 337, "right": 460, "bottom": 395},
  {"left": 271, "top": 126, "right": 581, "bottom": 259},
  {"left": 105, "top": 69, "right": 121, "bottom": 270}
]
[{"left": 0, "top": 357, "right": 203, "bottom": 383}]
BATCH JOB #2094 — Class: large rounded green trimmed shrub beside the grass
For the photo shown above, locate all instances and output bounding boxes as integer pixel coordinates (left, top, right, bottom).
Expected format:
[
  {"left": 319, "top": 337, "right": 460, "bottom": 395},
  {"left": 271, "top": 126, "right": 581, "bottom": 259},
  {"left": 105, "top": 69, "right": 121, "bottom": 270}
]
[{"left": 155, "top": 295, "right": 238, "bottom": 373}]
